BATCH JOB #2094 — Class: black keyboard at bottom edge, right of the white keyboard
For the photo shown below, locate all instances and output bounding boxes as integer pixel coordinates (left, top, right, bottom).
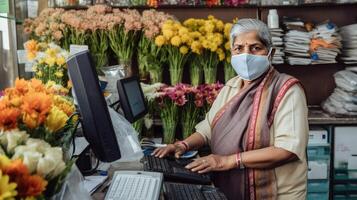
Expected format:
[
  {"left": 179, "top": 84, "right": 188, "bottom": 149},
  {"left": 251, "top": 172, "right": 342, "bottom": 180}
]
[{"left": 164, "top": 182, "right": 227, "bottom": 200}]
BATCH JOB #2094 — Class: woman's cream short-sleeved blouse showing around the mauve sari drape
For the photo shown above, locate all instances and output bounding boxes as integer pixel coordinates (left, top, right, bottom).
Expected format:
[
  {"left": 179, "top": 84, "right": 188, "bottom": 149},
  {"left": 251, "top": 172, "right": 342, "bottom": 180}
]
[{"left": 196, "top": 77, "right": 309, "bottom": 200}]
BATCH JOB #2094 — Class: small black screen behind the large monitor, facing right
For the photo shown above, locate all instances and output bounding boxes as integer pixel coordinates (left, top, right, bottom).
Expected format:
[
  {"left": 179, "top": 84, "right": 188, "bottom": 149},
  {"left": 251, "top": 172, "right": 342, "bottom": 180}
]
[{"left": 117, "top": 77, "right": 147, "bottom": 123}]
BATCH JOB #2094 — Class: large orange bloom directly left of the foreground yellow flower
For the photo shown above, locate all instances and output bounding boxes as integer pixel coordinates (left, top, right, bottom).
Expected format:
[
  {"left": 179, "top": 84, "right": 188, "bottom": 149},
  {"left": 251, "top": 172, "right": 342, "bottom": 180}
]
[{"left": 21, "top": 92, "right": 52, "bottom": 128}]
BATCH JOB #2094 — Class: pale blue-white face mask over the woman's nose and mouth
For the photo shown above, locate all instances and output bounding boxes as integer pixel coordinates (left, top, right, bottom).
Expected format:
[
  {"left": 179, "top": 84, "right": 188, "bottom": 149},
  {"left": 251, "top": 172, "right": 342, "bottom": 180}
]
[{"left": 231, "top": 49, "right": 271, "bottom": 81}]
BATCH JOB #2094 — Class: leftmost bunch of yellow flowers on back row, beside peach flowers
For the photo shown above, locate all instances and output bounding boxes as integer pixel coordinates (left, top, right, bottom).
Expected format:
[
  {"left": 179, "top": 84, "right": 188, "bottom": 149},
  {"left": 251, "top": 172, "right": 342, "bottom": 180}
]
[{"left": 155, "top": 20, "right": 192, "bottom": 85}]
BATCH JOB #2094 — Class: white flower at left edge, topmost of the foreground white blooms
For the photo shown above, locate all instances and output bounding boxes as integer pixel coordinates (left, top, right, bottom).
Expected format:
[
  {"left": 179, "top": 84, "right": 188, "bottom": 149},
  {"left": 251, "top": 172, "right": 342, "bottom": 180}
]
[{"left": 0, "top": 129, "right": 29, "bottom": 153}]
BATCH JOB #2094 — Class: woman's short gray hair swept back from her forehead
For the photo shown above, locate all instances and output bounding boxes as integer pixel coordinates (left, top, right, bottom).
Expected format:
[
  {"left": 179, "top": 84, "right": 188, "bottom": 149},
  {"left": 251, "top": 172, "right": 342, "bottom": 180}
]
[{"left": 230, "top": 19, "right": 272, "bottom": 49}]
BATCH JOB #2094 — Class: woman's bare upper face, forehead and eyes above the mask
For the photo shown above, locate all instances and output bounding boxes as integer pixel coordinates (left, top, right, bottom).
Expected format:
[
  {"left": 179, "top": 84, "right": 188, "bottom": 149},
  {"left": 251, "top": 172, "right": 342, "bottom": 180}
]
[{"left": 231, "top": 31, "right": 269, "bottom": 55}]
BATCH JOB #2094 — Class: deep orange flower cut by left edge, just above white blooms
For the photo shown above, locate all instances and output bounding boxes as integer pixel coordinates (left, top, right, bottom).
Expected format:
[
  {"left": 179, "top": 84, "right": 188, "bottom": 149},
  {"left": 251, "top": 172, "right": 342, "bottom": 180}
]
[{"left": 0, "top": 108, "right": 21, "bottom": 129}]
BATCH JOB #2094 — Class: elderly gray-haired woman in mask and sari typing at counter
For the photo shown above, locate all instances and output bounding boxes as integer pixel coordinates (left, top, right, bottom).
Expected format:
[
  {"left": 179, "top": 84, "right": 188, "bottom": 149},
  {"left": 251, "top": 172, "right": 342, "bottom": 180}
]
[{"left": 153, "top": 19, "right": 308, "bottom": 200}]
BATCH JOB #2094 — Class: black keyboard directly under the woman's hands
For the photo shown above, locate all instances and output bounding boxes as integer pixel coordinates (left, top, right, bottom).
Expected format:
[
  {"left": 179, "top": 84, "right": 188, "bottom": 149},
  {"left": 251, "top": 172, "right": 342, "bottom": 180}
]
[{"left": 143, "top": 156, "right": 211, "bottom": 185}]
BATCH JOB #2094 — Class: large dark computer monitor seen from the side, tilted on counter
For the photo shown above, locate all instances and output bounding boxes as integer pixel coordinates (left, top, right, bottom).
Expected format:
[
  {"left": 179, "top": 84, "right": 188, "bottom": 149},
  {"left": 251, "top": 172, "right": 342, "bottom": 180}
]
[{"left": 67, "top": 51, "right": 121, "bottom": 162}]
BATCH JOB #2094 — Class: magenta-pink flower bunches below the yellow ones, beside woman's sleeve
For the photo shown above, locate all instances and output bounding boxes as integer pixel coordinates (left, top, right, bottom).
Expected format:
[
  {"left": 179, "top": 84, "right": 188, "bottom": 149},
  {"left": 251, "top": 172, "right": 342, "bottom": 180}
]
[{"left": 155, "top": 83, "right": 223, "bottom": 144}]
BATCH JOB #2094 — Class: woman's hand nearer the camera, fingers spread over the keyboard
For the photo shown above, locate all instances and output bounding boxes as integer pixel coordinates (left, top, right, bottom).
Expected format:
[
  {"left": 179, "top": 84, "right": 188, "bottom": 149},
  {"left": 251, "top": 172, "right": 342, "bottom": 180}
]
[{"left": 186, "top": 154, "right": 237, "bottom": 173}]
